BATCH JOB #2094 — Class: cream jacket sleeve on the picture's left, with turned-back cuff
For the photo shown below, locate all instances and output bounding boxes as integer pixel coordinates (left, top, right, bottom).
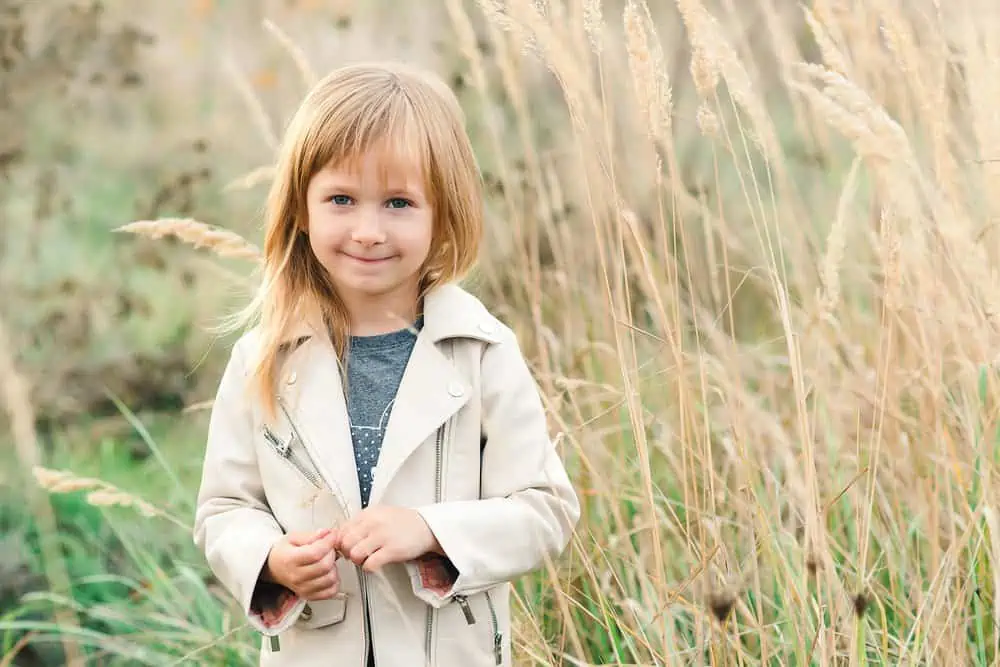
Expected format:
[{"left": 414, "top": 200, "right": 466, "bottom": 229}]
[{"left": 194, "top": 341, "right": 302, "bottom": 634}]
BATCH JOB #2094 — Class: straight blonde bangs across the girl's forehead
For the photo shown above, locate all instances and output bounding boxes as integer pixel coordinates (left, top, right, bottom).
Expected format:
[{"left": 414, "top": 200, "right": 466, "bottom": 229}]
[{"left": 303, "top": 94, "right": 435, "bottom": 199}]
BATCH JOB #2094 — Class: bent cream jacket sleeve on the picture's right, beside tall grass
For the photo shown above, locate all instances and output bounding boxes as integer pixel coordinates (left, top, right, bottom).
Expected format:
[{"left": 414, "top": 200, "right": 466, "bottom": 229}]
[{"left": 409, "top": 327, "right": 580, "bottom": 606}]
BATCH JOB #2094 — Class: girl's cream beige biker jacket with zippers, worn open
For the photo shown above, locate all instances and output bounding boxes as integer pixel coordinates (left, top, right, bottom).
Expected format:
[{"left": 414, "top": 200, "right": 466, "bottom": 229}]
[{"left": 194, "top": 286, "right": 580, "bottom": 667}]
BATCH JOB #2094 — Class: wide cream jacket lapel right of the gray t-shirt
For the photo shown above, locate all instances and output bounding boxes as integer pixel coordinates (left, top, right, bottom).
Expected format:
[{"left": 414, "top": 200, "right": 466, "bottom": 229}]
[{"left": 370, "top": 331, "right": 471, "bottom": 504}]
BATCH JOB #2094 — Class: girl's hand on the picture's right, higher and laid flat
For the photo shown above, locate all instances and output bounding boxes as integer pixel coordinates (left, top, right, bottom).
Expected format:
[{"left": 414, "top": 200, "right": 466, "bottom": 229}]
[{"left": 336, "top": 505, "right": 441, "bottom": 572}]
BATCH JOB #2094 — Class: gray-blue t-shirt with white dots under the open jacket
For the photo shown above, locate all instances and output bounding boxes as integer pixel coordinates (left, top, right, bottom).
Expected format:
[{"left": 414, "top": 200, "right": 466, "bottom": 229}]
[{"left": 347, "top": 320, "right": 423, "bottom": 507}]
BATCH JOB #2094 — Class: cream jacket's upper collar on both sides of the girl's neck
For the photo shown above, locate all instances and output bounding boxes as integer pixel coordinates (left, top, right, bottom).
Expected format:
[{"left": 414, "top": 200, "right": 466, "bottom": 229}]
[{"left": 281, "top": 284, "right": 499, "bottom": 345}]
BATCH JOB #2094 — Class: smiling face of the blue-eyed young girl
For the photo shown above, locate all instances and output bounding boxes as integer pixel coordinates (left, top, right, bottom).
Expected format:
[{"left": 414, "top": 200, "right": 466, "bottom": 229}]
[{"left": 306, "top": 154, "right": 434, "bottom": 317}]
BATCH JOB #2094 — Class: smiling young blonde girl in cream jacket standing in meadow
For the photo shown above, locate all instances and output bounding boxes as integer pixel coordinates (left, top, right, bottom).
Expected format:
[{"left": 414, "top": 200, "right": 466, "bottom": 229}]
[{"left": 194, "top": 65, "right": 580, "bottom": 667}]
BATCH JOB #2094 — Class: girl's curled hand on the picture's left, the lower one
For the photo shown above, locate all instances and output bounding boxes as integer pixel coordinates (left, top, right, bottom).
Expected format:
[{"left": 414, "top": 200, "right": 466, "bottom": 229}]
[{"left": 265, "top": 530, "right": 340, "bottom": 601}]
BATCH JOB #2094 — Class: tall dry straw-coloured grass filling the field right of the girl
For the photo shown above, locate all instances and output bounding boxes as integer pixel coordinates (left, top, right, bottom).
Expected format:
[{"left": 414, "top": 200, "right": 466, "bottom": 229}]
[{"left": 9, "top": 0, "right": 1000, "bottom": 665}]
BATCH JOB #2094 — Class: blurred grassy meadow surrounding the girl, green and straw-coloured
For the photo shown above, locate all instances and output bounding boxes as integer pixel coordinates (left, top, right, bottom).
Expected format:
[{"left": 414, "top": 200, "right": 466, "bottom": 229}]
[{"left": 0, "top": 0, "right": 1000, "bottom": 667}]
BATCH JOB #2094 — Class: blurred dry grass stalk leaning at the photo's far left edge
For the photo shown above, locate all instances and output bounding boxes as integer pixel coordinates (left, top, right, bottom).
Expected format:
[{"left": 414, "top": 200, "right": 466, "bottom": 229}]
[{"left": 0, "top": 321, "right": 83, "bottom": 665}]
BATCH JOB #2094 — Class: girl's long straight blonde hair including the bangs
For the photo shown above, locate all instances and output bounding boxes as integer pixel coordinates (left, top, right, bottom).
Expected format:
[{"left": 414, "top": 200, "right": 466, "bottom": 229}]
[{"left": 239, "top": 63, "right": 483, "bottom": 415}]
